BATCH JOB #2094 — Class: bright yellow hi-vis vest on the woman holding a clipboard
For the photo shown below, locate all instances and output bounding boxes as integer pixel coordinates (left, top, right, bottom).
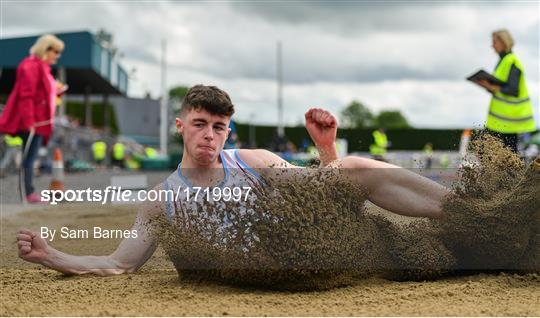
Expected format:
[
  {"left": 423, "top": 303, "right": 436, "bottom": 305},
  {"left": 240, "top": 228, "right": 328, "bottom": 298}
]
[{"left": 486, "top": 53, "right": 536, "bottom": 134}]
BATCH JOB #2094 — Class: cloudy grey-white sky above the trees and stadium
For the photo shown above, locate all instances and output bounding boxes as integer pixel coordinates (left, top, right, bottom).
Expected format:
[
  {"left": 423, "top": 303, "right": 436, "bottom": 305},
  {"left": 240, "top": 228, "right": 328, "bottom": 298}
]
[{"left": 0, "top": 0, "right": 540, "bottom": 128}]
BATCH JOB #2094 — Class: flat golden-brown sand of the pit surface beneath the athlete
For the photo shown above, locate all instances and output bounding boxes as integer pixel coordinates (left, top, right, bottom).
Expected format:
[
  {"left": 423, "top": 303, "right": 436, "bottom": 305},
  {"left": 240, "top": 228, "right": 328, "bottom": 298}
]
[{"left": 0, "top": 205, "right": 540, "bottom": 316}]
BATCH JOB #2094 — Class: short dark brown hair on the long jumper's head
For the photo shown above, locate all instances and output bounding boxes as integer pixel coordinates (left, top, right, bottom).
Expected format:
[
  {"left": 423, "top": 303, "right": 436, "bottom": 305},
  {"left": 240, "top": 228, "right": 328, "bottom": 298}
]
[{"left": 180, "top": 84, "right": 234, "bottom": 117}]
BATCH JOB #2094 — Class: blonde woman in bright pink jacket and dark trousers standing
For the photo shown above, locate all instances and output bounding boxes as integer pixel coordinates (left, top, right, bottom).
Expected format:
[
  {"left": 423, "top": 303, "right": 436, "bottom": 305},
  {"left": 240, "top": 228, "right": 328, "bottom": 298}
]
[{"left": 0, "top": 34, "right": 64, "bottom": 203}]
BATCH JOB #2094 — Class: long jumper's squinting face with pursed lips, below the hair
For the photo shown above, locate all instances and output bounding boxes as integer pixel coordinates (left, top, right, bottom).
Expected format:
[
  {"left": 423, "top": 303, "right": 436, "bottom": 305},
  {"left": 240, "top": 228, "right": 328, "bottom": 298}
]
[{"left": 176, "top": 109, "right": 230, "bottom": 165}]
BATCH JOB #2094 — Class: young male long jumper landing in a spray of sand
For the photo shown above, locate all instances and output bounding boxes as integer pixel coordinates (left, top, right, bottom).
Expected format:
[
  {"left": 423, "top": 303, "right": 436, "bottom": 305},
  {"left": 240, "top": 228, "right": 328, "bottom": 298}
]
[{"left": 17, "top": 85, "right": 449, "bottom": 275}]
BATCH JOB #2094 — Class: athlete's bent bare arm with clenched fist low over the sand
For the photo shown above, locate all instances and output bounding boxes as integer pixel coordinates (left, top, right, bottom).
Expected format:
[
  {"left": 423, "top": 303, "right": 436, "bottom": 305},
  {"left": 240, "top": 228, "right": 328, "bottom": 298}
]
[{"left": 17, "top": 185, "right": 163, "bottom": 276}]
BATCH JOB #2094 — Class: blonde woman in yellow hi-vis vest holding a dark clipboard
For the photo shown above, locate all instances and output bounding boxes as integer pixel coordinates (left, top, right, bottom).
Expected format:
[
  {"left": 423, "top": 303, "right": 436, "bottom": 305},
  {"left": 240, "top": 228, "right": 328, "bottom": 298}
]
[{"left": 476, "top": 30, "right": 536, "bottom": 153}]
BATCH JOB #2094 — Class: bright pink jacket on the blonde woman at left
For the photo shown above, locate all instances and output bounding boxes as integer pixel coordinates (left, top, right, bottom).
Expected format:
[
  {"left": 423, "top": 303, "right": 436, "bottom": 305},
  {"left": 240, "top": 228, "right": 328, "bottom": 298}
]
[{"left": 0, "top": 55, "right": 56, "bottom": 144}]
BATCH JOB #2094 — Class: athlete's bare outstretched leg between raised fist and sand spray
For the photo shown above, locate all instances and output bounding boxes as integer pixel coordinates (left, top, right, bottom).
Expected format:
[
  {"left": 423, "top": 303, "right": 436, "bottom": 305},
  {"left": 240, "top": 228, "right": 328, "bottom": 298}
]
[{"left": 331, "top": 156, "right": 450, "bottom": 218}]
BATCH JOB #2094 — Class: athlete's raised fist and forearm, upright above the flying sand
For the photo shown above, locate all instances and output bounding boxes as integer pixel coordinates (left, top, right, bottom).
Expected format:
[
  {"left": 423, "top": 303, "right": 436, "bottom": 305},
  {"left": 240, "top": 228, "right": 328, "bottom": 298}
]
[{"left": 305, "top": 108, "right": 338, "bottom": 167}]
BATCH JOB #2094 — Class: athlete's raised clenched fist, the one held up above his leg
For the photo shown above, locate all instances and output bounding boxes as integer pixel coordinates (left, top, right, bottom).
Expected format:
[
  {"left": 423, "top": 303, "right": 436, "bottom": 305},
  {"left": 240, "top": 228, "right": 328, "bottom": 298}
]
[{"left": 305, "top": 108, "right": 338, "bottom": 148}]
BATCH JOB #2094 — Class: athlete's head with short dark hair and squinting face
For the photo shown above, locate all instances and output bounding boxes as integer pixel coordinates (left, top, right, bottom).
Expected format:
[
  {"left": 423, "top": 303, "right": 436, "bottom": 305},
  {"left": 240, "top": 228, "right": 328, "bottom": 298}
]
[{"left": 176, "top": 85, "right": 234, "bottom": 165}]
